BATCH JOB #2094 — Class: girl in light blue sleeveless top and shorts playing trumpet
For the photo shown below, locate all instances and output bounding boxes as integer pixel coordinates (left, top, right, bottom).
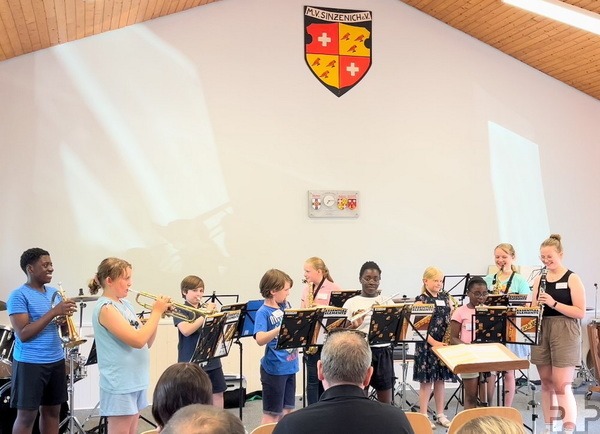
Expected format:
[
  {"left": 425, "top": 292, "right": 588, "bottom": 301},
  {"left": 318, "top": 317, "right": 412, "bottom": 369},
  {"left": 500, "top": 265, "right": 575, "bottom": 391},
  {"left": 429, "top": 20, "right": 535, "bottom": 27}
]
[{"left": 88, "top": 258, "right": 170, "bottom": 434}]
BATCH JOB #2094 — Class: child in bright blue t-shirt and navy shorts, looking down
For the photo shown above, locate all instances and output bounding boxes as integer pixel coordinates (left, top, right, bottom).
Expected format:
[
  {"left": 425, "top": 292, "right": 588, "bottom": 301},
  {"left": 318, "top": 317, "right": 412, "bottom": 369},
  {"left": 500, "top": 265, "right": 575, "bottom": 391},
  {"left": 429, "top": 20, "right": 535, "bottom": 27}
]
[{"left": 254, "top": 269, "right": 298, "bottom": 424}]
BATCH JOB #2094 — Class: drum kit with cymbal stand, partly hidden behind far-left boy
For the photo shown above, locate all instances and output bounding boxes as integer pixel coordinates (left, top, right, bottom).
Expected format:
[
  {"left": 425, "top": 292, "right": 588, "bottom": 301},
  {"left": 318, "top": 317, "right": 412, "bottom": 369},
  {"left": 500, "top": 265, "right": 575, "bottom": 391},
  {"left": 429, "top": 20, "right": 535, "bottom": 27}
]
[{"left": 0, "top": 290, "right": 98, "bottom": 434}]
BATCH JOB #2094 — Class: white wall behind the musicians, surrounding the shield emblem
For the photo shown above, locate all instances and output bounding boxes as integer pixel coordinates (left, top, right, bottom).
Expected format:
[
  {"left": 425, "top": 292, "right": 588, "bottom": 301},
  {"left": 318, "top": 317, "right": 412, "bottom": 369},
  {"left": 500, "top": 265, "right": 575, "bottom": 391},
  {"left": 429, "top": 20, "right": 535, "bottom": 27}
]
[{"left": 0, "top": 0, "right": 600, "bottom": 406}]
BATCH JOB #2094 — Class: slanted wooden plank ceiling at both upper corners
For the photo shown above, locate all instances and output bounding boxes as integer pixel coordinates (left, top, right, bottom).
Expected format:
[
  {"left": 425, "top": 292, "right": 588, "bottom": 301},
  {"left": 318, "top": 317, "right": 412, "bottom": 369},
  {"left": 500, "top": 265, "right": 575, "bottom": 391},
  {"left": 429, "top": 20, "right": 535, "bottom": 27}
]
[{"left": 0, "top": 0, "right": 600, "bottom": 100}]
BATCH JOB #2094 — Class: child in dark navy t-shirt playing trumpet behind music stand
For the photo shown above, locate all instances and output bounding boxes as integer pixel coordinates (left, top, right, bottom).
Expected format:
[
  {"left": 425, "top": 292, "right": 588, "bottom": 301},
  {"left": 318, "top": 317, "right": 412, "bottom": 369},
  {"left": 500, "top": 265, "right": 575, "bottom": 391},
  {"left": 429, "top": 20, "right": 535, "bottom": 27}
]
[{"left": 173, "top": 275, "right": 227, "bottom": 408}]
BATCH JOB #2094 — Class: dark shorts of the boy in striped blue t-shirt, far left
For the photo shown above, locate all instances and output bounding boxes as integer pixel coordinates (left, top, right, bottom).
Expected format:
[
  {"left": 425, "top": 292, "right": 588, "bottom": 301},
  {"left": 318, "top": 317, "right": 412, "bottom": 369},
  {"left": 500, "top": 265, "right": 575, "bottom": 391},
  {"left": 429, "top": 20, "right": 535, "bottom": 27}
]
[{"left": 10, "top": 360, "right": 68, "bottom": 410}]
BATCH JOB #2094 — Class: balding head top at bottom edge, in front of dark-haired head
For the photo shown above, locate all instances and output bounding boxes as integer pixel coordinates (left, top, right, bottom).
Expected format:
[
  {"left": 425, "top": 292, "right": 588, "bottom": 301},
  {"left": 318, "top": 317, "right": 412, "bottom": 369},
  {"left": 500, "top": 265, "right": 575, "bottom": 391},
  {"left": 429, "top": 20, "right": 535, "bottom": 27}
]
[{"left": 161, "top": 404, "right": 246, "bottom": 434}]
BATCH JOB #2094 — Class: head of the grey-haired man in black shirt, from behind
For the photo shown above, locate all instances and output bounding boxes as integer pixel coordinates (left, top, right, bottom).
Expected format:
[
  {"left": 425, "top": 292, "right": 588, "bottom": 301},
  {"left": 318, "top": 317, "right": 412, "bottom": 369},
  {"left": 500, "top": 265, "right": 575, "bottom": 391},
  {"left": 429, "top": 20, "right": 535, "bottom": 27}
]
[{"left": 317, "top": 330, "right": 373, "bottom": 389}]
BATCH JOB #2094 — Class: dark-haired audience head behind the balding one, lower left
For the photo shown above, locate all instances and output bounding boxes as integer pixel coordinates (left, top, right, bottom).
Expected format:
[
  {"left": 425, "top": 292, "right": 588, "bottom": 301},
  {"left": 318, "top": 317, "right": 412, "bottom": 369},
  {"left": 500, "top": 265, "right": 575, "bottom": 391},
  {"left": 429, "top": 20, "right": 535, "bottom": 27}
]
[{"left": 152, "top": 363, "right": 212, "bottom": 431}]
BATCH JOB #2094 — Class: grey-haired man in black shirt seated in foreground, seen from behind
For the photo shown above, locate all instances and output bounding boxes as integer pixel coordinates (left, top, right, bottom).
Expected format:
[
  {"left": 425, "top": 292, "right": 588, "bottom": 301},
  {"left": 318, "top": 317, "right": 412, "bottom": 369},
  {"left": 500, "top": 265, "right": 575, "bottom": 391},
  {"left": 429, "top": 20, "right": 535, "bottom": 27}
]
[{"left": 274, "top": 329, "right": 413, "bottom": 434}]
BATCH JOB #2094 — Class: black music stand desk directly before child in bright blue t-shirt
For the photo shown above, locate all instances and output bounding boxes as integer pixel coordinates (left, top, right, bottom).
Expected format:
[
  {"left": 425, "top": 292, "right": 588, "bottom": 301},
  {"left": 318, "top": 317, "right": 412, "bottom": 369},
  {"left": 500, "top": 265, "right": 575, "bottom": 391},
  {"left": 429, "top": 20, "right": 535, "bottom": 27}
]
[{"left": 276, "top": 307, "right": 318, "bottom": 350}]
